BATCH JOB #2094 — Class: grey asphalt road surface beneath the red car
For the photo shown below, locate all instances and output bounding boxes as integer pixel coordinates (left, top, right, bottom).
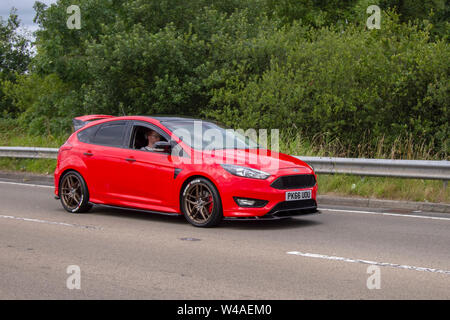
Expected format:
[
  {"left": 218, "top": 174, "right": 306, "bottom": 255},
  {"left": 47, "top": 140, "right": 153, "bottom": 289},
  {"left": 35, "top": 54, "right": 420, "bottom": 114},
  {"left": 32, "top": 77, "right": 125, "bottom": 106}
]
[{"left": 0, "top": 179, "right": 450, "bottom": 299}]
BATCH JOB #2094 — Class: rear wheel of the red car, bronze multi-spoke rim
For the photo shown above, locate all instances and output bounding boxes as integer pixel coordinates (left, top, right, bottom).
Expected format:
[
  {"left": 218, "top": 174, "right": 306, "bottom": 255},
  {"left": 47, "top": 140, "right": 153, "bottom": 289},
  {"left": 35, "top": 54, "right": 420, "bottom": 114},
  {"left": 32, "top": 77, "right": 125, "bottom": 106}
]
[{"left": 59, "top": 171, "right": 92, "bottom": 213}]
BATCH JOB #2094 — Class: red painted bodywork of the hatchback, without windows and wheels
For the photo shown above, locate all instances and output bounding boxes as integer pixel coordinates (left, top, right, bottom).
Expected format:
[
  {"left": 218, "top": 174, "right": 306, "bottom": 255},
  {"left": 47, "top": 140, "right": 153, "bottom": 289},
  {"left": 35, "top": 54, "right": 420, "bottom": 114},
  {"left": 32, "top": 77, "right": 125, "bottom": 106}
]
[{"left": 54, "top": 116, "right": 317, "bottom": 217}]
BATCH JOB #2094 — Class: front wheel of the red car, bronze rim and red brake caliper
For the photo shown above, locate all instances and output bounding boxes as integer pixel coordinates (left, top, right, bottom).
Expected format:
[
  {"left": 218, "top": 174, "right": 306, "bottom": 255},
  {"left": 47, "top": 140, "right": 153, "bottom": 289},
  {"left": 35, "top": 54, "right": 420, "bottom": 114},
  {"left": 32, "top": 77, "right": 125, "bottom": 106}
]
[{"left": 180, "top": 178, "right": 223, "bottom": 228}]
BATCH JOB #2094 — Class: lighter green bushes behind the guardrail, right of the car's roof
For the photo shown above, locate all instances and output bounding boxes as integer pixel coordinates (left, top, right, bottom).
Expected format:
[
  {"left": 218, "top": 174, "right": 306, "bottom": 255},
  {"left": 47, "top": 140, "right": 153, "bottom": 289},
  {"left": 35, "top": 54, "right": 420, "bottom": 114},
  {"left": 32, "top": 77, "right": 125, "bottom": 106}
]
[{"left": 206, "top": 11, "right": 450, "bottom": 156}]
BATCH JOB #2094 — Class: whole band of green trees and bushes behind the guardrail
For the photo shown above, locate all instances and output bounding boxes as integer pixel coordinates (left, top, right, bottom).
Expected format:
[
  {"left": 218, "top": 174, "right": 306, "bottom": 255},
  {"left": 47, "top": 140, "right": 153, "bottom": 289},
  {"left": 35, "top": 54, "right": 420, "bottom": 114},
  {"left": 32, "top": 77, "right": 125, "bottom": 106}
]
[{"left": 2, "top": 0, "right": 450, "bottom": 158}]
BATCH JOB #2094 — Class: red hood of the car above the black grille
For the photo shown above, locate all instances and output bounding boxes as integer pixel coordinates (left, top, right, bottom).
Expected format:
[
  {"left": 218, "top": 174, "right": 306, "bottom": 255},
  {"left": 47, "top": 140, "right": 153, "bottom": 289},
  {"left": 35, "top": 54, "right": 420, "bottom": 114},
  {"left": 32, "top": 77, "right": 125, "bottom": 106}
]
[{"left": 203, "top": 149, "right": 313, "bottom": 174}]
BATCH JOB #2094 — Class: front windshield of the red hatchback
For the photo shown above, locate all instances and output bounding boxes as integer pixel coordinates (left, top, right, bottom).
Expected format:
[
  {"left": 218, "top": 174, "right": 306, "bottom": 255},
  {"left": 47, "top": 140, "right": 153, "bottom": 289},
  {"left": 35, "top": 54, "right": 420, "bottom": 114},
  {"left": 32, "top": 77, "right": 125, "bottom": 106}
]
[{"left": 162, "top": 120, "right": 259, "bottom": 150}]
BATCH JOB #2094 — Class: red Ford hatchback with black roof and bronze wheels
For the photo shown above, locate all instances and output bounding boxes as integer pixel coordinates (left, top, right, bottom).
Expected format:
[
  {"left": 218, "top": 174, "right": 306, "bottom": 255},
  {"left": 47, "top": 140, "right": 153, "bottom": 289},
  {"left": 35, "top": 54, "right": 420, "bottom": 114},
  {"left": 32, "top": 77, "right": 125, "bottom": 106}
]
[{"left": 55, "top": 115, "right": 317, "bottom": 227}]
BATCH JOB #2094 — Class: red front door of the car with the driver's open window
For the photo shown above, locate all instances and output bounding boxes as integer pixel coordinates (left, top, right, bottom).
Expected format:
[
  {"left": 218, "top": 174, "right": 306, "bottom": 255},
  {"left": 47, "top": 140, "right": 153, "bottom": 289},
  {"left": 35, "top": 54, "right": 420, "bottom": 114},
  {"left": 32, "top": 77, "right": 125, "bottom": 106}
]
[{"left": 124, "top": 121, "right": 178, "bottom": 211}]
